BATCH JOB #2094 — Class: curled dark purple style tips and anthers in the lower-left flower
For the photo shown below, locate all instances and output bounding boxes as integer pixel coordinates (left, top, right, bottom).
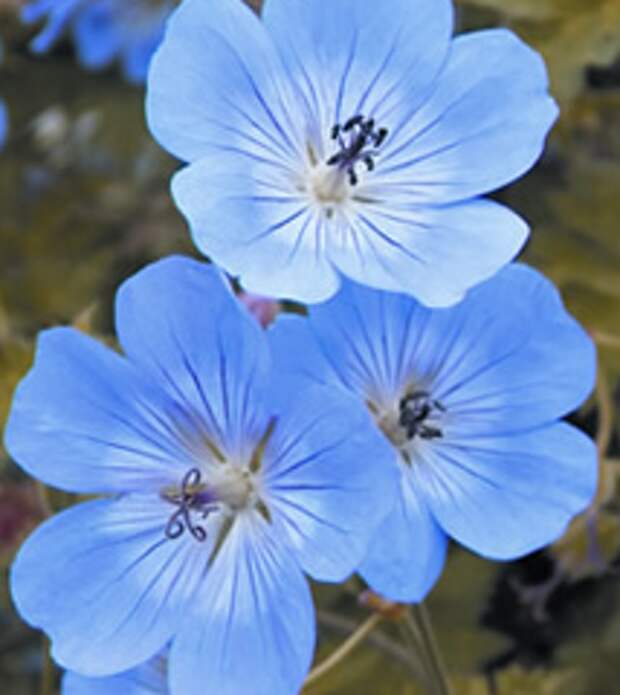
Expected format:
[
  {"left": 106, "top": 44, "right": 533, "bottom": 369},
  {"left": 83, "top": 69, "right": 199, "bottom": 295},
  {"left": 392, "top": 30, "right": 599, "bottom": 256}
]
[{"left": 162, "top": 468, "right": 218, "bottom": 542}]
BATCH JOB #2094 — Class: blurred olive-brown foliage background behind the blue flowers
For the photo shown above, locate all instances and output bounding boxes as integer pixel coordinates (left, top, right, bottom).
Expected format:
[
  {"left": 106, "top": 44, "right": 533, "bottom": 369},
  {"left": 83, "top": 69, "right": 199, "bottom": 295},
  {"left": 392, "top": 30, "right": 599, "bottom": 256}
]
[{"left": 0, "top": 0, "right": 620, "bottom": 695}]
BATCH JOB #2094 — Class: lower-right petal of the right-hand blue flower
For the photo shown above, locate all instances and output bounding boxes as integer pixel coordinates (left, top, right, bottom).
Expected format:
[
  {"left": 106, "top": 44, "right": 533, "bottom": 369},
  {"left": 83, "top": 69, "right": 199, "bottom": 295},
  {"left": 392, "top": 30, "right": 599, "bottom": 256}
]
[{"left": 417, "top": 423, "right": 597, "bottom": 560}]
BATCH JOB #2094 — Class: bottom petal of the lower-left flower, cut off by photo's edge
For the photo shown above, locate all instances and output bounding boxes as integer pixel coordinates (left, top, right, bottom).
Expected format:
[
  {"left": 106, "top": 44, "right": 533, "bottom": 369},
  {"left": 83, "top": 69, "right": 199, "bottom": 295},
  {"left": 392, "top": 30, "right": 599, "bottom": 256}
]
[{"left": 170, "top": 516, "right": 315, "bottom": 695}]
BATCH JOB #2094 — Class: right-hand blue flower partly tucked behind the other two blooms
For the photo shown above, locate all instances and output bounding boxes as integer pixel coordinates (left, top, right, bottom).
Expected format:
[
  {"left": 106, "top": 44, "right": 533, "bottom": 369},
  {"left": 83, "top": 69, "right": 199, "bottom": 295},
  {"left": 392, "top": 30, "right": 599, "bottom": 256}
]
[{"left": 270, "top": 265, "right": 597, "bottom": 601}]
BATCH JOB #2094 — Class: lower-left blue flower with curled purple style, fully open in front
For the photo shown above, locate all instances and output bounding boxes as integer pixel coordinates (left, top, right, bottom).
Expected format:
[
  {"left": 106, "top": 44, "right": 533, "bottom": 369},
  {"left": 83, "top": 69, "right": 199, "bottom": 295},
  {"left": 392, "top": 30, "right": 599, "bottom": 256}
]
[{"left": 5, "top": 258, "right": 397, "bottom": 695}]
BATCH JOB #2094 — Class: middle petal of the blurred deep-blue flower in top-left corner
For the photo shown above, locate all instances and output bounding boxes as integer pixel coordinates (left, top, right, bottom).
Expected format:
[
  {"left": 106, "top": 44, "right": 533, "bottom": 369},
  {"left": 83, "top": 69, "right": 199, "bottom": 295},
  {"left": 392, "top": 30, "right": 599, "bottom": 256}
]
[{"left": 73, "top": 3, "right": 121, "bottom": 70}]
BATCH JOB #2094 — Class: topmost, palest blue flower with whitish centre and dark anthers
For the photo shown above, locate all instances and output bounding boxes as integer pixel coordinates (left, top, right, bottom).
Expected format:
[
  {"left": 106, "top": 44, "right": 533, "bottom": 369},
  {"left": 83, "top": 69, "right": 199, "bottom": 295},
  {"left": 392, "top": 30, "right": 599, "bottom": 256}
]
[{"left": 147, "top": 0, "right": 557, "bottom": 306}]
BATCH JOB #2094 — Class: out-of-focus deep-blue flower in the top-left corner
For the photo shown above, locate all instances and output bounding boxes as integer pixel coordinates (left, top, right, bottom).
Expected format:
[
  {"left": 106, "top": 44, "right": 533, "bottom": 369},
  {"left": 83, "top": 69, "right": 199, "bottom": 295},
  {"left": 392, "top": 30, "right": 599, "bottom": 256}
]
[{"left": 22, "top": 0, "right": 174, "bottom": 83}]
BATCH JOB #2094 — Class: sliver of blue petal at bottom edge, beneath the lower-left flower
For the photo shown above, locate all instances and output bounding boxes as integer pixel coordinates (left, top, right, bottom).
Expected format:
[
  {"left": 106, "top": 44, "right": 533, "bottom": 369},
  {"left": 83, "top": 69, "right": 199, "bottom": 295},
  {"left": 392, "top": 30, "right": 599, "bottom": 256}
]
[{"left": 61, "top": 656, "right": 169, "bottom": 695}]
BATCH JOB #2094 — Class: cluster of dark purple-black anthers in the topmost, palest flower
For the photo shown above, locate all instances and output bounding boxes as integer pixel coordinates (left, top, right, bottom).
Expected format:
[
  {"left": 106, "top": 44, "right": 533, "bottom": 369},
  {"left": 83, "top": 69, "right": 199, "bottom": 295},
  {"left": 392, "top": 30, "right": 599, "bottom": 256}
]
[{"left": 327, "top": 114, "right": 388, "bottom": 186}]
